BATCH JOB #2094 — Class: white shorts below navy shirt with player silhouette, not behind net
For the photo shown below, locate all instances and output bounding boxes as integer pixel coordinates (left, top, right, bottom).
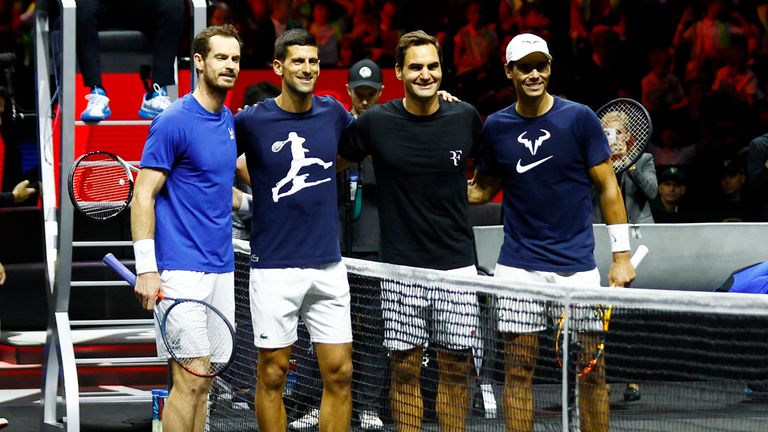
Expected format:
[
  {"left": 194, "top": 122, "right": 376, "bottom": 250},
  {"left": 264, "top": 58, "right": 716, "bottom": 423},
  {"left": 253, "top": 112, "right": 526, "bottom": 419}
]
[{"left": 250, "top": 261, "right": 352, "bottom": 348}]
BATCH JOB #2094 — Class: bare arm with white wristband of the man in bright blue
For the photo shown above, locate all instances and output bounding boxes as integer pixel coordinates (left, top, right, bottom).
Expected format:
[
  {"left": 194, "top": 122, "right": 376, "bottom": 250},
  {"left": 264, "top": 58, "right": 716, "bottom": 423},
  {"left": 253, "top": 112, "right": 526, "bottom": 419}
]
[{"left": 131, "top": 168, "right": 168, "bottom": 310}]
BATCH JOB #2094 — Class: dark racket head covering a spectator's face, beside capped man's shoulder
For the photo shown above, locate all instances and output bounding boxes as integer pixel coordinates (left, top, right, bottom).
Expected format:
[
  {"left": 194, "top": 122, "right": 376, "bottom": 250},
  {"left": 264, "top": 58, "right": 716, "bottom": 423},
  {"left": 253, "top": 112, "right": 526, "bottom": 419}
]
[{"left": 596, "top": 98, "right": 653, "bottom": 174}]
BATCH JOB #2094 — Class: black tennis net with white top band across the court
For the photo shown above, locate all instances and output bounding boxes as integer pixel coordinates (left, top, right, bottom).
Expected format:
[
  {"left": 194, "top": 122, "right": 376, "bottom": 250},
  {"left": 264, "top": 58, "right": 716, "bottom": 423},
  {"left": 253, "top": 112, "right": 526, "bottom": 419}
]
[{"left": 208, "top": 248, "right": 768, "bottom": 431}]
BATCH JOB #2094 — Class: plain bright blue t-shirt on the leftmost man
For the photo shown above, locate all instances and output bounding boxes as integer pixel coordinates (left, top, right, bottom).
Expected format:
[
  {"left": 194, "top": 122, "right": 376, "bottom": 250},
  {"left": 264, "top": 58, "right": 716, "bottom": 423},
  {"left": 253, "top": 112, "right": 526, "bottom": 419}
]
[{"left": 141, "top": 94, "right": 237, "bottom": 273}]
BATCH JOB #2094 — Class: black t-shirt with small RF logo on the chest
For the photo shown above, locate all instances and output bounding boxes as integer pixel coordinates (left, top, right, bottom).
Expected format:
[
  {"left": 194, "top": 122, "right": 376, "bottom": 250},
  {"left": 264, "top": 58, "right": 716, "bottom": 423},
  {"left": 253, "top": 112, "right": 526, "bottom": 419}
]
[{"left": 340, "top": 99, "right": 481, "bottom": 270}]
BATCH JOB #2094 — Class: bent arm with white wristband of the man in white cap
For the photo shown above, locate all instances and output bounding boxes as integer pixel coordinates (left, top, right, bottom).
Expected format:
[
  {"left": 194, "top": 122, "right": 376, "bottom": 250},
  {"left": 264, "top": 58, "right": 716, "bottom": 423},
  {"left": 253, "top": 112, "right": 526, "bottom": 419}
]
[{"left": 589, "top": 159, "right": 635, "bottom": 287}]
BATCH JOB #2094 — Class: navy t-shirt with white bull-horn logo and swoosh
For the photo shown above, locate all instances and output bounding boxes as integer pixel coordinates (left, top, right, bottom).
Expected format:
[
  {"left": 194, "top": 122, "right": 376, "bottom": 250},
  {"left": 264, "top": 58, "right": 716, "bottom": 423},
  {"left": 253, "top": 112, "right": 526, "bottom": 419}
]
[{"left": 478, "top": 97, "right": 611, "bottom": 272}]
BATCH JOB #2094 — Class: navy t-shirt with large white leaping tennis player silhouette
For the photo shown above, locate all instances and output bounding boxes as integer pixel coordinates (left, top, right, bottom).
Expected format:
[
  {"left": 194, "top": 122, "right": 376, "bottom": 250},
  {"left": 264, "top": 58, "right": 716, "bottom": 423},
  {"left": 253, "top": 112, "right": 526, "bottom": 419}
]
[{"left": 235, "top": 96, "right": 354, "bottom": 268}]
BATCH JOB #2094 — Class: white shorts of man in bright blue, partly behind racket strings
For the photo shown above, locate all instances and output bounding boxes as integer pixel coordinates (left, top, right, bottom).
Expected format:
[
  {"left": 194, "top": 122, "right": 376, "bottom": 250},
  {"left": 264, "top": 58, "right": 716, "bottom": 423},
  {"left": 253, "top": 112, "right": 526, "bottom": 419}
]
[{"left": 155, "top": 270, "right": 235, "bottom": 362}]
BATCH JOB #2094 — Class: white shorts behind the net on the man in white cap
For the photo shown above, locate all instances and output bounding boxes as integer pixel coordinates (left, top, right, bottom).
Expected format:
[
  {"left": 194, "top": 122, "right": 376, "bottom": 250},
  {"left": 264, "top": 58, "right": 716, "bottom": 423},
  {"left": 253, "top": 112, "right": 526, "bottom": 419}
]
[{"left": 493, "top": 263, "right": 603, "bottom": 333}]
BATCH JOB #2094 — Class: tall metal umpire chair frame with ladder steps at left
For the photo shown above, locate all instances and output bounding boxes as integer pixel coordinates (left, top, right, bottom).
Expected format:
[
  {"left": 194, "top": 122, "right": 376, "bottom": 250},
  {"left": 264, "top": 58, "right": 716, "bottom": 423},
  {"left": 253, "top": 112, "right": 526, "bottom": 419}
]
[{"left": 34, "top": 0, "right": 207, "bottom": 432}]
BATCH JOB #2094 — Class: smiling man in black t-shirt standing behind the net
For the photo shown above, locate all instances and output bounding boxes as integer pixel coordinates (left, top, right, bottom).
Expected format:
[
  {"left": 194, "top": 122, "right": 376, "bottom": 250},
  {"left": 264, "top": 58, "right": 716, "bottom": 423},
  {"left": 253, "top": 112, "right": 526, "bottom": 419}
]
[{"left": 340, "top": 31, "right": 481, "bottom": 431}]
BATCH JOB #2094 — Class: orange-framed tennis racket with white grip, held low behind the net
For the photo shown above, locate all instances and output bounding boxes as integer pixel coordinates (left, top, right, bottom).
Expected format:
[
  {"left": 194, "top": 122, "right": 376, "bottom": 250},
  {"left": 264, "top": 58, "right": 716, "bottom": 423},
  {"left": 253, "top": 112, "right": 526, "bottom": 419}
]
[{"left": 555, "top": 245, "right": 648, "bottom": 377}]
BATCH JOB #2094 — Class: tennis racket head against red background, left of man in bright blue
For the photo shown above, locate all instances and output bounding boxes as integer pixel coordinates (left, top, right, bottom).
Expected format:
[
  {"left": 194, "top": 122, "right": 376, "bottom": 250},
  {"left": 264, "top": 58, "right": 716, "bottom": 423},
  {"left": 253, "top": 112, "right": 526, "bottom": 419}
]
[{"left": 69, "top": 151, "right": 138, "bottom": 221}]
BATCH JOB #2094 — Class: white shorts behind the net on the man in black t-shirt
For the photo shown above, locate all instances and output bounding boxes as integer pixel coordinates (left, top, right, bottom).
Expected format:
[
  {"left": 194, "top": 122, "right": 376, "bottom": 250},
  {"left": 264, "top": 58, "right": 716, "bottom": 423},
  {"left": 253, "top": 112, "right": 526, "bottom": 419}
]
[{"left": 381, "top": 266, "right": 482, "bottom": 351}]
